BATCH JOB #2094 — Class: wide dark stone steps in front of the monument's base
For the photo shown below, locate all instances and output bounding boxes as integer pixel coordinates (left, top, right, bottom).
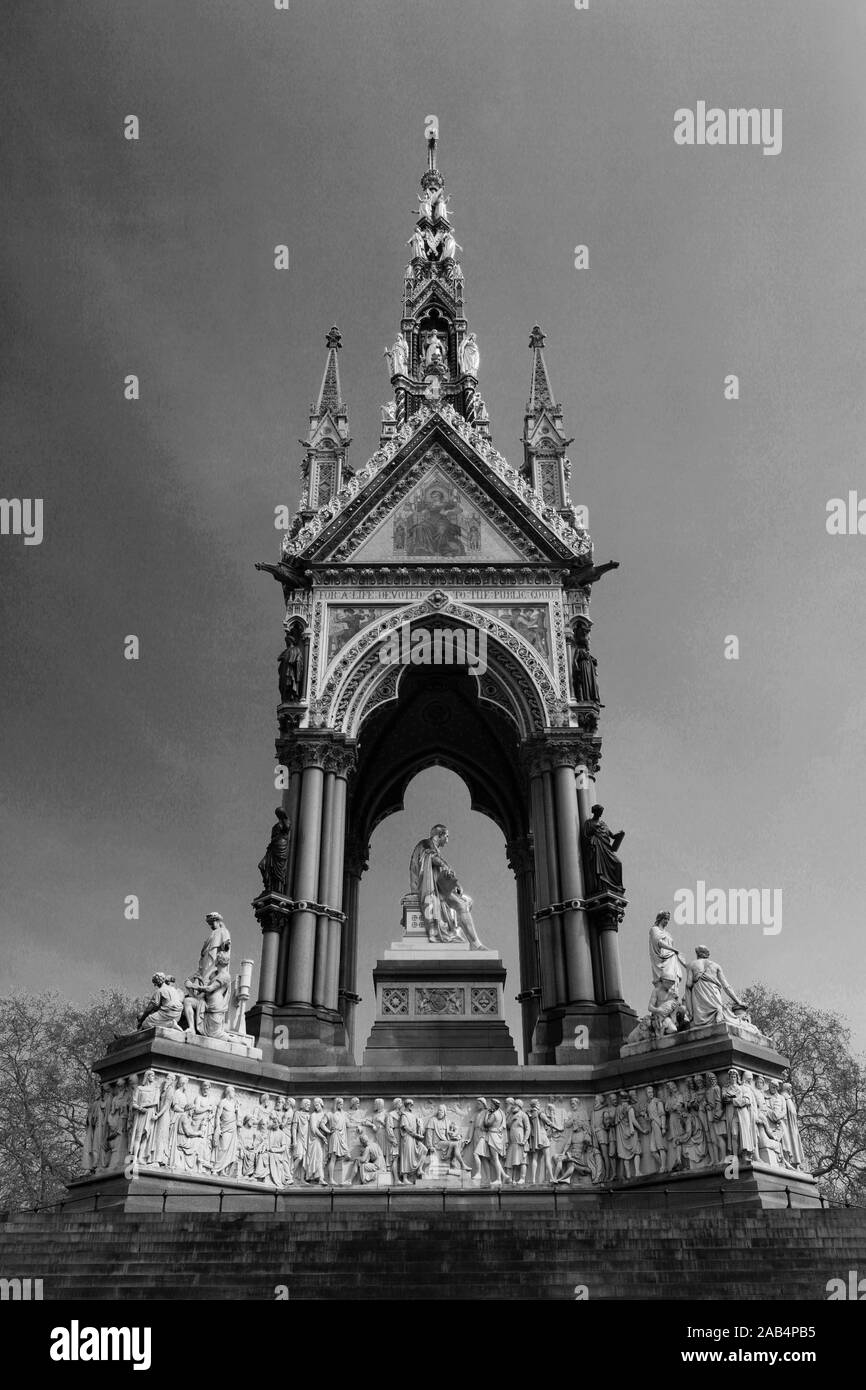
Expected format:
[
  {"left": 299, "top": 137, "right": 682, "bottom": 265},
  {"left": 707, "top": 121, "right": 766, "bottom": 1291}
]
[{"left": 0, "top": 1207, "right": 866, "bottom": 1301}]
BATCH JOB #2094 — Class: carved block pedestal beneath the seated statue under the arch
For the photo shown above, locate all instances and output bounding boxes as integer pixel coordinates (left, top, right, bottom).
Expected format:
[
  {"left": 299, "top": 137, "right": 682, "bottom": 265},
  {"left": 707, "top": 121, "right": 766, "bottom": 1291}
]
[{"left": 364, "top": 931, "right": 517, "bottom": 1066}]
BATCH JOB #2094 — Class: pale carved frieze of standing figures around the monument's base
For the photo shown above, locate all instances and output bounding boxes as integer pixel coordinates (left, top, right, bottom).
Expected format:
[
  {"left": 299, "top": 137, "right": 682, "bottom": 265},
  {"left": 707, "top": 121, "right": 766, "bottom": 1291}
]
[{"left": 82, "top": 1069, "right": 805, "bottom": 1190}]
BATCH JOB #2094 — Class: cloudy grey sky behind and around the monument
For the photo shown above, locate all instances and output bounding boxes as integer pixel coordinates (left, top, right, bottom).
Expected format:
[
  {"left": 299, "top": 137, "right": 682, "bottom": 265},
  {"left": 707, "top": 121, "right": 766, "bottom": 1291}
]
[{"left": 0, "top": 0, "right": 866, "bottom": 1041}]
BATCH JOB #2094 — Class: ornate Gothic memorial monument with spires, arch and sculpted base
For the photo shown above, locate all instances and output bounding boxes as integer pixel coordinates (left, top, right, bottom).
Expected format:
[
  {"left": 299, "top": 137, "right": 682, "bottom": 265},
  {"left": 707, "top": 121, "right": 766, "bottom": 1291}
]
[{"left": 71, "top": 125, "right": 816, "bottom": 1209}]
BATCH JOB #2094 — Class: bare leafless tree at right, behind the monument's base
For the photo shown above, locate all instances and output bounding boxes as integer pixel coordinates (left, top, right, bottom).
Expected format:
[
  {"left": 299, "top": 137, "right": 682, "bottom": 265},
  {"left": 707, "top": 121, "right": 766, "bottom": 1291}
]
[{"left": 745, "top": 984, "right": 866, "bottom": 1205}]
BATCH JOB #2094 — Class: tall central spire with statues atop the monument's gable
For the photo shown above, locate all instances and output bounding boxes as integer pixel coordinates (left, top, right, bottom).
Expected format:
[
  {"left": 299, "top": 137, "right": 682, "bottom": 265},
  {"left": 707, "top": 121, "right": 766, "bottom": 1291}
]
[{"left": 384, "top": 115, "right": 489, "bottom": 435}]
